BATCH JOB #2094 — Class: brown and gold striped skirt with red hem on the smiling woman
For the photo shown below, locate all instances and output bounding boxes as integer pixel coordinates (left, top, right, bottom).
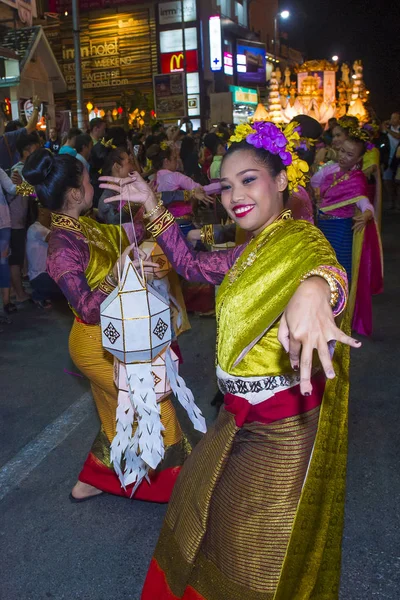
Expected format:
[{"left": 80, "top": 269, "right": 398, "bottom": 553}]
[{"left": 141, "top": 370, "right": 341, "bottom": 600}]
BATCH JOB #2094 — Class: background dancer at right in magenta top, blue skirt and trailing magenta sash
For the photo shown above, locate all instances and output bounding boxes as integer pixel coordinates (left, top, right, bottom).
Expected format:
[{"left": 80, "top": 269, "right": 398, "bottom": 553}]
[{"left": 311, "top": 129, "right": 383, "bottom": 335}]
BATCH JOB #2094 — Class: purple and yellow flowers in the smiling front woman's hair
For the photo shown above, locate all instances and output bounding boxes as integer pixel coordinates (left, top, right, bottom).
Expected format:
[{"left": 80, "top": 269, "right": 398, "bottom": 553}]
[{"left": 229, "top": 121, "right": 309, "bottom": 192}]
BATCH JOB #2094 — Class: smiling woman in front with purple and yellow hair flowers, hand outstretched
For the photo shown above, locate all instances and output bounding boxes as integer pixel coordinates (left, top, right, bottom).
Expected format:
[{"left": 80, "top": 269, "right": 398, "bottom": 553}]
[{"left": 101, "top": 123, "right": 359, "bottom": 600}]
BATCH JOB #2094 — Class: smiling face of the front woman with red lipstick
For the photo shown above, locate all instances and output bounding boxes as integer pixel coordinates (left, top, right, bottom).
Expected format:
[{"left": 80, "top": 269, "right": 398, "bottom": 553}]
[{"left": 221, "top": 150, "right": 287, "bottom": 235}]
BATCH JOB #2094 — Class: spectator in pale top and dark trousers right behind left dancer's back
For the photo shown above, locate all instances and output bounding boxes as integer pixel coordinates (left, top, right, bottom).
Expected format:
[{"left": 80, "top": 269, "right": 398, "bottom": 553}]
[{"left": 26, "top": 206, "right": 61, "bottom": 308}]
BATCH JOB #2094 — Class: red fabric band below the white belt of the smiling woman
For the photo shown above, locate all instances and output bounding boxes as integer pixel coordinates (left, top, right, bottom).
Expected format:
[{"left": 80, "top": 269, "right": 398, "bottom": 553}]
[{"left": 224, "top": 375, "right": 325, "bottom": 427}]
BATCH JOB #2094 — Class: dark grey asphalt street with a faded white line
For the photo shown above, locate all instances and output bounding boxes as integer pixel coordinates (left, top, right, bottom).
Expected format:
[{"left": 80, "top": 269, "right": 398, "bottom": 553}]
[{"left": 0, "top": 215, "right": 400, "bottom": 600}]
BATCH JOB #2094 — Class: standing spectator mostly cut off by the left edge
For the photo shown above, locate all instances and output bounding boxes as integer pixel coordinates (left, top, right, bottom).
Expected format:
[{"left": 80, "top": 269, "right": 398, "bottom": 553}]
[{"left": 0, "top": 169, "right": 17, "bottom": 313}]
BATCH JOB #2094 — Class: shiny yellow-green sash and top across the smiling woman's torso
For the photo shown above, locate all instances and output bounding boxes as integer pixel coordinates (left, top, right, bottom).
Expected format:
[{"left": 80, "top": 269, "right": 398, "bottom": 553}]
[{"left": 217, "top": 211, "right": 339, "bottom": 377}]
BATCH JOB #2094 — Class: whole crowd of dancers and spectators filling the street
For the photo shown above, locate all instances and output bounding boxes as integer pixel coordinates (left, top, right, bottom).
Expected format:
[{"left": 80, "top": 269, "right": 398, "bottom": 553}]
[{"left": 0, "top": 99, "right": 394, "bottom": 600}]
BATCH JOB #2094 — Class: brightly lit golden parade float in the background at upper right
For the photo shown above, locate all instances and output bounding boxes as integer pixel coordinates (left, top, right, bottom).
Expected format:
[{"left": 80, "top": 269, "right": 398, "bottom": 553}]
[{"left": 267, "top": 60, "right": 369, "bottom": 124}]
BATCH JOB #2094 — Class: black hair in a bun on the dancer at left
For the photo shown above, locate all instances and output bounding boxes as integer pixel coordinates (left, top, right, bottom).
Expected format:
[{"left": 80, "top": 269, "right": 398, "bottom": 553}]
[{"left": 22, "top": 148, "right": 84, "bottom": 211}]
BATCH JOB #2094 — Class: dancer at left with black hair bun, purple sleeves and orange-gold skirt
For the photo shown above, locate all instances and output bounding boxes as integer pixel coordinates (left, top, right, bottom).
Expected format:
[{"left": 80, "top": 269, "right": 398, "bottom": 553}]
[{"left": 24, "top": 150, "right": 190, "bottom": 502}]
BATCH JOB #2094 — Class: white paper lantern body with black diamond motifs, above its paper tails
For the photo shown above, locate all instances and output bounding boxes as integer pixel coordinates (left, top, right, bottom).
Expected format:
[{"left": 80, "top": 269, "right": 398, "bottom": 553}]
[{"left": 100, "top": 258, "right": 171, "bottom": 364}]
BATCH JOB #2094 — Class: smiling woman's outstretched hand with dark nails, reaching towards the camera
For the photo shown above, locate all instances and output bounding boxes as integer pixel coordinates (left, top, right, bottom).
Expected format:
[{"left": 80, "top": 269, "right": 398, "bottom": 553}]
[{"left": 278, "top": 277, "right": 361, "bottom": 396}]
